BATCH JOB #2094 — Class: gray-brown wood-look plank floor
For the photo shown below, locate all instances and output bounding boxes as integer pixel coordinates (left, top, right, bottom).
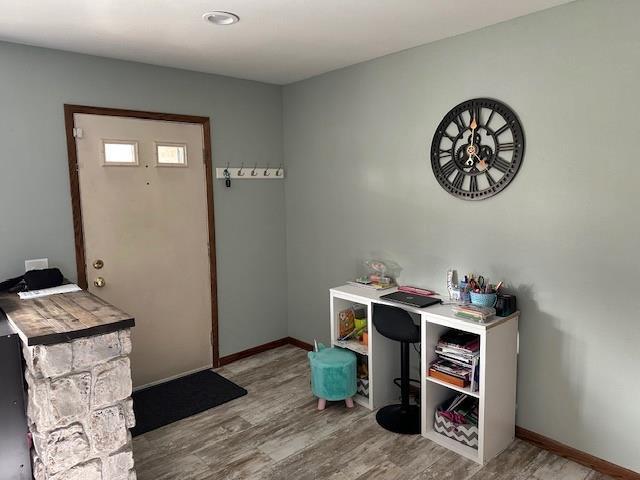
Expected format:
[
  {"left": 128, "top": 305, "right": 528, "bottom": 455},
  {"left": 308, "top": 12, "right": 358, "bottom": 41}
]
[{"left": 133, "top": 346, "right": 611, "bottom": 480}]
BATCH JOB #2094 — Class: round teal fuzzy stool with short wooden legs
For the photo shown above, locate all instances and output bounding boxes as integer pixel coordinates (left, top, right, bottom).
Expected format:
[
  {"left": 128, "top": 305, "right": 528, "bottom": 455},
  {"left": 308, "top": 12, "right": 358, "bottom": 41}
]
[{"left": 309, "top": 343, "right": 357, "bottom": 410}]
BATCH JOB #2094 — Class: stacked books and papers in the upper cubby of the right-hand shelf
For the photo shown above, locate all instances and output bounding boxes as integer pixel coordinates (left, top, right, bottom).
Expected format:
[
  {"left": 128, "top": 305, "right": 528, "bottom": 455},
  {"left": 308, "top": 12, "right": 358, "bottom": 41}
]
[{"left": 428, "top": 330, "right": 480, "bottom": 391}]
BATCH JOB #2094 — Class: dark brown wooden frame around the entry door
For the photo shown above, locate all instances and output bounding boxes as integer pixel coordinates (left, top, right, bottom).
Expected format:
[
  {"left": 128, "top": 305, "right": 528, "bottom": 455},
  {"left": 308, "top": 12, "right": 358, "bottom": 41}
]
[{"left": 64, "top": 104, "right": 220, "bottom": 368}]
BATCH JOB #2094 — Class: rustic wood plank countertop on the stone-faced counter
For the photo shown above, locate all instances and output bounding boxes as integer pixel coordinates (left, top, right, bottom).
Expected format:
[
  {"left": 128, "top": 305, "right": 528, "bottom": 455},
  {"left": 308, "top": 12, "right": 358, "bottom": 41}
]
[{"left": 0, "top": 290, "right": 135, "bottom": 345}]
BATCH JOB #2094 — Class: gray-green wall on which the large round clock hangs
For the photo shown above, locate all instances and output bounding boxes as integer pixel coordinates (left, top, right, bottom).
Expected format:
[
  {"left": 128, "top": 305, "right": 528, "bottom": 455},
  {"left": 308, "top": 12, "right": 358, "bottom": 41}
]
[{"left": 284, "top": 0, "right": 640, "bottom": 471}]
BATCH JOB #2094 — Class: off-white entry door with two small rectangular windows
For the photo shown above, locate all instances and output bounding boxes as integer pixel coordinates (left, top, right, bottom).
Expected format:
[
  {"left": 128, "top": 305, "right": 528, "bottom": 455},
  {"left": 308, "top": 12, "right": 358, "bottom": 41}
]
[{"left": 74, "top": 114, "right": 212, "bottom": 386}]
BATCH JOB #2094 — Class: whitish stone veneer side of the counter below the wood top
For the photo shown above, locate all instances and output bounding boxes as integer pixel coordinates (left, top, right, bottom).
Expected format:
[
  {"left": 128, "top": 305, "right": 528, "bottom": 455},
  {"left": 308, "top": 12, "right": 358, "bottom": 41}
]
[{"left": 23, "top": 329, "right": 136, "bottom": 480}]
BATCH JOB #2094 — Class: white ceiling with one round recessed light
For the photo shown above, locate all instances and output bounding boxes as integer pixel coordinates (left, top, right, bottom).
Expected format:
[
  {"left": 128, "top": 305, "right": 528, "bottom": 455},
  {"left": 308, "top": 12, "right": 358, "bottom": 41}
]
[{"left": 0, "top": 0, "right": 570, "bottom": 84}]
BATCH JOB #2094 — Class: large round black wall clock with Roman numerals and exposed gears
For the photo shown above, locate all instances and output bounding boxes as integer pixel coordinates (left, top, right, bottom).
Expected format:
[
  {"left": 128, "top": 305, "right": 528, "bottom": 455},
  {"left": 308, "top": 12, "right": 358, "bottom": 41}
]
[{"left": 431, "top": 98, "right": 524, "bottom": 200}]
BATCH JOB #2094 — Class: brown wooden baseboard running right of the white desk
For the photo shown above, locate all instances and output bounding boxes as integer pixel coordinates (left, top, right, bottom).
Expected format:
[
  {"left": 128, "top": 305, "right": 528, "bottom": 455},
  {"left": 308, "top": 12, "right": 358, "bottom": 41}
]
[{"left": 516, "top": 426, "right": 640, "bottom": 480}]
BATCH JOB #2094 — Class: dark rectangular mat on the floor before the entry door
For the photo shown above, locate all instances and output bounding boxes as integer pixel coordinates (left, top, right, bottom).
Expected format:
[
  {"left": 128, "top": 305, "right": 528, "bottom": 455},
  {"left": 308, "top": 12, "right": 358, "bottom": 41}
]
[{"left": 131, "top": 370, "right": 247, "bottom": 437}]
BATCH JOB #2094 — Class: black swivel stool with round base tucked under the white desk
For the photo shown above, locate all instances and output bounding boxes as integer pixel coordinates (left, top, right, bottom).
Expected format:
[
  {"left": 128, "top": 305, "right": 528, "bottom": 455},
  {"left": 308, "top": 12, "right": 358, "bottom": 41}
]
[{"left": 373, "top": 304, "right": 420, "bottom": 434}]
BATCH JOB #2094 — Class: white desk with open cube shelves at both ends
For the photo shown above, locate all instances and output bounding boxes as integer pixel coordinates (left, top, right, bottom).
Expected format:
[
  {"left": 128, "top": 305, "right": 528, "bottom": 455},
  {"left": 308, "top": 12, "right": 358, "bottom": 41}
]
[{"left": 330, "top": 285, "right": 519, "bottom": 465}]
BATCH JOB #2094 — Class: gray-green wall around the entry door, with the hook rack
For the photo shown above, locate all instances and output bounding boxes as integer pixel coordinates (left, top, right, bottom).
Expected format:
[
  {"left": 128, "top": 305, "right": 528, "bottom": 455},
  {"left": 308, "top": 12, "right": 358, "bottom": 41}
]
[{"left": 0, "top": 43, "right": 287, "bottom": 355}]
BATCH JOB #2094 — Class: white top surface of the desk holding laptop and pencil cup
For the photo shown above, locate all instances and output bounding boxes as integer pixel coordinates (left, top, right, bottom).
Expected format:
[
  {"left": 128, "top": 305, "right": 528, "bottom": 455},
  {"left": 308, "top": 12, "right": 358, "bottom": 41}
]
[{"left": 330, "top": 285, "right": 520, "bottom": 330}]
